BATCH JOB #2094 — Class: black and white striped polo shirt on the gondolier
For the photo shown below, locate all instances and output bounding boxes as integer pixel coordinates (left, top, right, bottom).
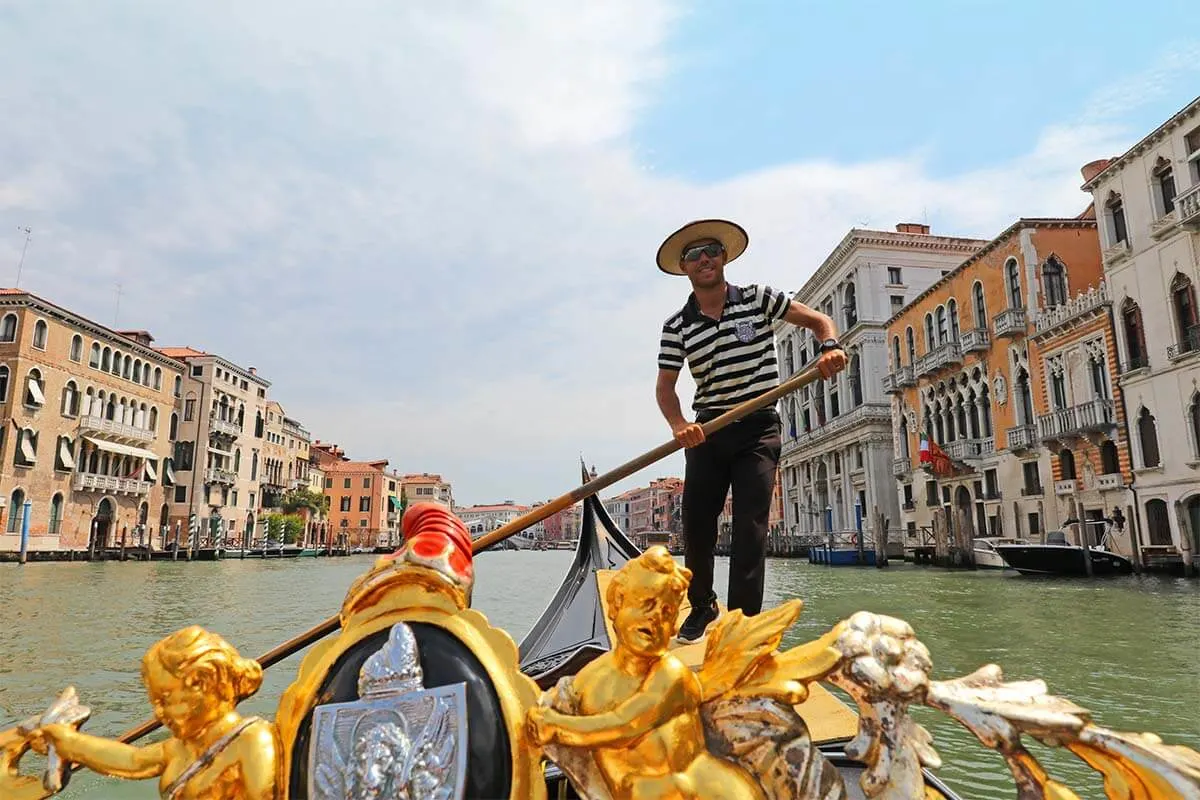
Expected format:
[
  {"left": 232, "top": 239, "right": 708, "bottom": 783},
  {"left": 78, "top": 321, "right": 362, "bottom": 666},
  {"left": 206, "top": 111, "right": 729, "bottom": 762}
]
[{"left": 659, "top": 283, "right": 791, "bottom": 411}]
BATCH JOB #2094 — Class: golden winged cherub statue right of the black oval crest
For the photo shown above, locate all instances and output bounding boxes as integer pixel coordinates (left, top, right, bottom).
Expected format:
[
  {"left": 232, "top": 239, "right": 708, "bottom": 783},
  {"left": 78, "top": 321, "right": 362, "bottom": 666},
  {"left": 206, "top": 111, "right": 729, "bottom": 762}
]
[{"left": 527, "top": 546, "right": 845, "bottom": 800}]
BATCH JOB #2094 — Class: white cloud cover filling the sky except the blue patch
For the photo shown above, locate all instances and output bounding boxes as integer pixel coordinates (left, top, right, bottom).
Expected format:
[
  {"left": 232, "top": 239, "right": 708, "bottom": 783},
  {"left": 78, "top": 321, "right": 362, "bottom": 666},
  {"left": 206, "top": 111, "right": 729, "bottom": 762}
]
[{"left": 0, "top": 0, "right": 1195, "bottom": 501}]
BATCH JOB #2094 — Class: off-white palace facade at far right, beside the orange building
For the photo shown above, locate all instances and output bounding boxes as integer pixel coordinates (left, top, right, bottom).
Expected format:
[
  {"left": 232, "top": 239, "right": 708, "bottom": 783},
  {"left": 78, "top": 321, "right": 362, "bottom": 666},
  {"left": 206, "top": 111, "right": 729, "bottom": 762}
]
[{"left": 1084, "top": 98, "right": 1200, "bottom": 569}]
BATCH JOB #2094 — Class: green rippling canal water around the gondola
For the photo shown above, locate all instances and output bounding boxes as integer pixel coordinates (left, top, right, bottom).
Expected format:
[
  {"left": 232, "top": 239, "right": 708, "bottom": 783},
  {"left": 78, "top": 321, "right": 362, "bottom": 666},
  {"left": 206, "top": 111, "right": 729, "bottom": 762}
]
[{"left": 0, "top": 552, "right": 1200, "bottom": 800}]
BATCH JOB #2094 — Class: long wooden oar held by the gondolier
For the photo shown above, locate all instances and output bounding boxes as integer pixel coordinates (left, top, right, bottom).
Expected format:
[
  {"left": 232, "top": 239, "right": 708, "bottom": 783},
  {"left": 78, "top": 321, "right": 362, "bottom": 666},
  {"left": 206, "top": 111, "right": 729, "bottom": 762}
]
[{"left": 108, "top": 363, "right": 821, "bottom": 753}]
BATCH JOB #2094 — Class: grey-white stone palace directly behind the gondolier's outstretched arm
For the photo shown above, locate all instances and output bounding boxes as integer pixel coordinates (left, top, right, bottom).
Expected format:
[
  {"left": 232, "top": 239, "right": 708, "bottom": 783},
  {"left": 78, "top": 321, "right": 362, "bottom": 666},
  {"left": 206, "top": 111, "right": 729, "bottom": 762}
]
[{"left": 775, "top": 223, "right": 985, "bottom": 536}]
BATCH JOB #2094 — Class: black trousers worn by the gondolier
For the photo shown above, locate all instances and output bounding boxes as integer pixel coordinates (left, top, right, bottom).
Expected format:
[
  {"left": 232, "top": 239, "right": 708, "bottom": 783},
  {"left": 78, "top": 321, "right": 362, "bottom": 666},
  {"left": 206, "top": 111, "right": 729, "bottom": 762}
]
[{"left": 683, "top": 409, "right": 782, "bottom": 616}]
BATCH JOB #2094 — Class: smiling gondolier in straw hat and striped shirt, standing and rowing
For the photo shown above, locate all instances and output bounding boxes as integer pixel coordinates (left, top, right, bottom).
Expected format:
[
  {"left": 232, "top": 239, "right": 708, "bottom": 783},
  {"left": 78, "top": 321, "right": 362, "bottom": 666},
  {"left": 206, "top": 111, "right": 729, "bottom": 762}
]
[{"left": 655, "top": 219, "right": 846, "bottom": 640}]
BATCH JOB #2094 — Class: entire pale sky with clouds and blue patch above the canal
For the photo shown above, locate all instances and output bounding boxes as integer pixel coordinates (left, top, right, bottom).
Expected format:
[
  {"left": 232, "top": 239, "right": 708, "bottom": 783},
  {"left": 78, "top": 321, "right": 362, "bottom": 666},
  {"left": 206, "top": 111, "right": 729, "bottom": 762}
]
[{"left": 0, "top": 0, "right": 1200, "bottom": 504}]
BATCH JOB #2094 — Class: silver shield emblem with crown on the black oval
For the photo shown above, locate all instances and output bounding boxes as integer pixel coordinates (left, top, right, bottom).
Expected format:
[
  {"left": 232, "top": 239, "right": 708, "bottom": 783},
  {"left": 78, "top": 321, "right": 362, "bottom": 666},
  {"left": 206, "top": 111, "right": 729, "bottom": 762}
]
[{"left": 308, "top": 622, "right": 467, "bottom": 800}]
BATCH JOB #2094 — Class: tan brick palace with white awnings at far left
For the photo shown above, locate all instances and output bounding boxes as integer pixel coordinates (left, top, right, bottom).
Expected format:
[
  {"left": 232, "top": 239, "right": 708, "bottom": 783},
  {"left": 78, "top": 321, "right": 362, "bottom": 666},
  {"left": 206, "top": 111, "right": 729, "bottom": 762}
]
[{"left": 0, "top": 289, "right": 182, "bottom": 552}]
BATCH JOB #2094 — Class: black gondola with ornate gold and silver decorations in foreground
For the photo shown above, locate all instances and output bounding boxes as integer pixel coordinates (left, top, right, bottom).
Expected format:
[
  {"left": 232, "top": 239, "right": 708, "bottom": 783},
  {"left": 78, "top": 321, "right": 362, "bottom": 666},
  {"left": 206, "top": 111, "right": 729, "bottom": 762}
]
[{"left": 0, "top": 470, "right": 1200, "bottom": 800}]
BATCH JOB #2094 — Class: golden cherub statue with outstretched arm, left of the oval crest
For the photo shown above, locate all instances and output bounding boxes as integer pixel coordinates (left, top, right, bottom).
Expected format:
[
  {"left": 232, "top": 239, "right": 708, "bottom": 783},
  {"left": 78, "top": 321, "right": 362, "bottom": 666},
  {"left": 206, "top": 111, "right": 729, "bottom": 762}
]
[{"left": 28, "top": 626, "right": 281, "bottom": 800}]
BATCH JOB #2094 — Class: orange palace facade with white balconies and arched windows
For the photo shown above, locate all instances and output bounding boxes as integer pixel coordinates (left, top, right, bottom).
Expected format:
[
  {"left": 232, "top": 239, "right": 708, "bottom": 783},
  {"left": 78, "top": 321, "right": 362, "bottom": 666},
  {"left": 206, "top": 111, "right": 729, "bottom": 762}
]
[{"left": 884, "top": 209, "right": 1130, "bottom": 560}]
